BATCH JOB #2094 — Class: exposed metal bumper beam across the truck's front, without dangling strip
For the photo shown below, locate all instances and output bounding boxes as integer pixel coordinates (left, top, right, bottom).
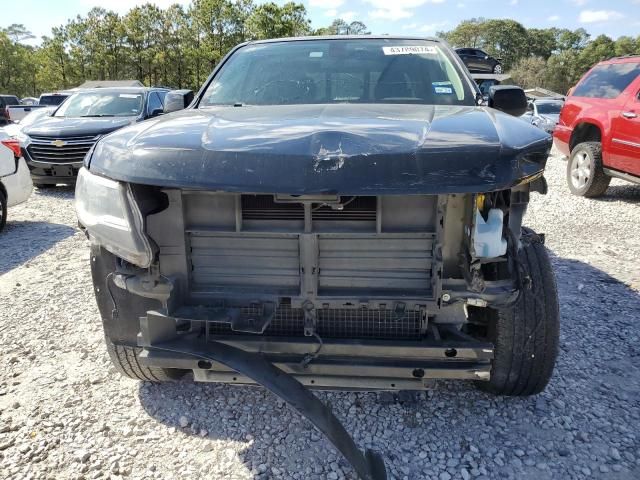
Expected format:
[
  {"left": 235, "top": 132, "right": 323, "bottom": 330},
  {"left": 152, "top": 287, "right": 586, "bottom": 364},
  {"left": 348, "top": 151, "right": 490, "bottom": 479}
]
[{"left": 141, "top": 312, "right": 493, "bottom": 390}]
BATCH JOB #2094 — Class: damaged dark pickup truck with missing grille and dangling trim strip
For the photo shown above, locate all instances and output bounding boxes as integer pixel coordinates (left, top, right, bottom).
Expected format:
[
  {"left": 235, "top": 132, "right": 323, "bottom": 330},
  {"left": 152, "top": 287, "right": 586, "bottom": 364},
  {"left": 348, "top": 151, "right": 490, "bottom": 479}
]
[{"left": 76, "top": 36, "right": 559, "bottom": 478}]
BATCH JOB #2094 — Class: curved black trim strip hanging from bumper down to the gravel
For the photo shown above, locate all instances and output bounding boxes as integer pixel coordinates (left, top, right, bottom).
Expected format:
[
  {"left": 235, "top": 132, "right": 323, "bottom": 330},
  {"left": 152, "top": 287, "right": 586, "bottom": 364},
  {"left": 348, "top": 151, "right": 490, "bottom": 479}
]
[{"left": 147, "top": 341, "right": 387, "bottom": 480}]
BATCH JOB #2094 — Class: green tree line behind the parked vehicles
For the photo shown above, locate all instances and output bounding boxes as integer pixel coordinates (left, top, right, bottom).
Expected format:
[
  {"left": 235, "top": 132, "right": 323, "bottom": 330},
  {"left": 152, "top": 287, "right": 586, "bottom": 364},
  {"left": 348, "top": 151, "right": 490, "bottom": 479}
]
[{"left": 0, "top": 5, "right": 640, "bottom": 97}]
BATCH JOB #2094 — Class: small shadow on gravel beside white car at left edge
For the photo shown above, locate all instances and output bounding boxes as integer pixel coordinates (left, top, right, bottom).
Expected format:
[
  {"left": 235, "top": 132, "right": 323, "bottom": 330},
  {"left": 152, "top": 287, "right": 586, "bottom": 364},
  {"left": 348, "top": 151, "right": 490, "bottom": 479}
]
[{"left": 0, "top": 220, "right": 76, "bottom": 275}]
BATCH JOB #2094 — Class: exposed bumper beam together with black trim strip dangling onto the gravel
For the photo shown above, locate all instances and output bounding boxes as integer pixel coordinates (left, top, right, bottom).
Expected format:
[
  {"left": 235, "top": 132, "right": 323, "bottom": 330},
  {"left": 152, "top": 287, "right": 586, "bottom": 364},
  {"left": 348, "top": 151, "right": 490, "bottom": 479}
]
[{"left": 140, "top": 312, "right": 493, "bottom": 480}]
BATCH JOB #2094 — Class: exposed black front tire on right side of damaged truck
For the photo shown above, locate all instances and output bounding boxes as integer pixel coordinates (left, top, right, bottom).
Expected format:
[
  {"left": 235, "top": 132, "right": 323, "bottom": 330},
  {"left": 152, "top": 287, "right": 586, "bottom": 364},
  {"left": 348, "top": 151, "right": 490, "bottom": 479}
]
[{"left": 476, "top": 229, "right": 560, "bottom": 396}]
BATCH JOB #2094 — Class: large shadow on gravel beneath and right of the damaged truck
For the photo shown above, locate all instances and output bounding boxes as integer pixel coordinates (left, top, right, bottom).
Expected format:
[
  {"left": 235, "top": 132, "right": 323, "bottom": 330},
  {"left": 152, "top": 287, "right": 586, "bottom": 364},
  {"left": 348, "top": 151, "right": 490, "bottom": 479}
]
[{"left": 139, "top": 256, "right": 640, "bottom": 480}]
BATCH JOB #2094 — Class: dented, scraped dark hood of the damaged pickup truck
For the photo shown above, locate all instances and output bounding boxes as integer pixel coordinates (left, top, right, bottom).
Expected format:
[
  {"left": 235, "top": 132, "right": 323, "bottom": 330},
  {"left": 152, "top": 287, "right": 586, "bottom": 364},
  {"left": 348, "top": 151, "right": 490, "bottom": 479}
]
[{"left": 87, "top": 104, "right": 551, "bottom": 195}]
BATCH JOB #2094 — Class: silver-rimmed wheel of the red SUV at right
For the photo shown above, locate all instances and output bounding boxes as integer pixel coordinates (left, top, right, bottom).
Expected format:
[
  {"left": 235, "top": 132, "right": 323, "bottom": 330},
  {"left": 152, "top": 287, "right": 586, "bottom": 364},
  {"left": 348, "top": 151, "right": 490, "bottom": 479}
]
[{"left": 567, "top": 142, "right": 611, "bottom": 198}]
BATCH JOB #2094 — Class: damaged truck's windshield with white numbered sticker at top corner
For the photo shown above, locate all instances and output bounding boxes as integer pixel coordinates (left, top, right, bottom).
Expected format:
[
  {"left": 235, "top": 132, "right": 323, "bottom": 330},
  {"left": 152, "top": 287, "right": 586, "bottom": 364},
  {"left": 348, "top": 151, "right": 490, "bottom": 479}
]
[{"left": 200, "top": 39, "right": 475, "bottom": 107}]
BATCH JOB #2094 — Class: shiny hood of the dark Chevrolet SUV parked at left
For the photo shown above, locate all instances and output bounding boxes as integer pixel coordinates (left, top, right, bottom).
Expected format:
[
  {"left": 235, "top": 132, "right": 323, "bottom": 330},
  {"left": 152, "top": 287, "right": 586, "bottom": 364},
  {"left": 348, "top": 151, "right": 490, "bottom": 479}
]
[{"left": 23, "top": 117, "right": 136, "bottom": 138}]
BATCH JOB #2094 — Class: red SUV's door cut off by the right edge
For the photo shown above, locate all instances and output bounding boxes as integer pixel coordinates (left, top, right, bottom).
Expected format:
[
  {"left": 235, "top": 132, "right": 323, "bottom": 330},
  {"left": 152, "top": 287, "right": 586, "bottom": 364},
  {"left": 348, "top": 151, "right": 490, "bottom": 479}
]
[{"left": 608, "top": 77, "right": 640, "bottom": 177}]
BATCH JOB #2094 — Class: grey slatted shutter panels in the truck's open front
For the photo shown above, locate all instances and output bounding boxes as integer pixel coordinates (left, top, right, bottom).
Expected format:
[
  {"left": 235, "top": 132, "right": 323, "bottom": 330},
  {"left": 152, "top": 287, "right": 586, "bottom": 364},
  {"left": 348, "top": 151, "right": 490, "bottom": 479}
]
[{"left": 188, "top": 231, "right": 434, "bottom": 297}]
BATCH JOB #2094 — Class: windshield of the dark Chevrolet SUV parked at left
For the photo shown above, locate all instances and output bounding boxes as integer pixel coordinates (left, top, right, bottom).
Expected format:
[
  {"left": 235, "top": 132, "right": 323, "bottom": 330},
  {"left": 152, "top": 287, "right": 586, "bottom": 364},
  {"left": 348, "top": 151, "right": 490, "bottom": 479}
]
[{"left": 55, "top": 92, "right": 143, "bottom": 117}]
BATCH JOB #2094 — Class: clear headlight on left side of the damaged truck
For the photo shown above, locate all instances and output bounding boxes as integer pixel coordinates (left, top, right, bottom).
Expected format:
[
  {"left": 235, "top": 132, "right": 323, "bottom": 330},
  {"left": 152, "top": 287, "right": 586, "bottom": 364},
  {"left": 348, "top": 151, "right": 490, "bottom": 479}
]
[{"left": 75, "top": 168, "right": 153, "bottom": 268}]
